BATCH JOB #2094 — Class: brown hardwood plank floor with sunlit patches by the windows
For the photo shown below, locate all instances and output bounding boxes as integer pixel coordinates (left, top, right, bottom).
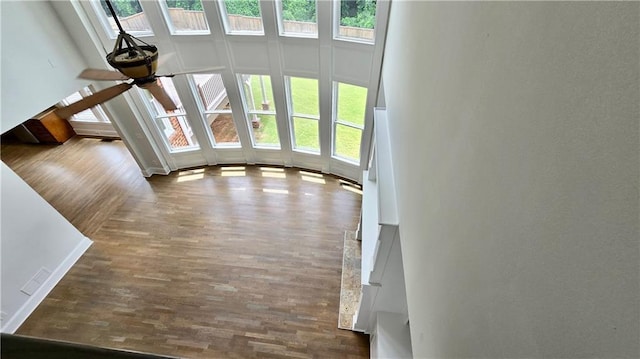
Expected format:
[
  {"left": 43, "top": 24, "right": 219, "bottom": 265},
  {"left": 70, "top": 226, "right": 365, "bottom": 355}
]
[{"left": 1, "top": 138, "right": 369, "bottom": 358}]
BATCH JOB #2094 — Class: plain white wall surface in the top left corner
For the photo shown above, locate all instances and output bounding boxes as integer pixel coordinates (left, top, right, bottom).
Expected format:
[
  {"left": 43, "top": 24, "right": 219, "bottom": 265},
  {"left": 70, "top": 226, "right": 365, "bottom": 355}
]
[{"left": 0, "top": 1, "right": 87, "bottom": 133}]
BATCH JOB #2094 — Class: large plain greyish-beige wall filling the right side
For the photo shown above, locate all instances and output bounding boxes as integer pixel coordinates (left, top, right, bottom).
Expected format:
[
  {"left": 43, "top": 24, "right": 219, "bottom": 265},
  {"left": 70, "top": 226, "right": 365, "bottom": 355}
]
[{"left": 383, "top": 1, "right": 640, "bottom": 358}]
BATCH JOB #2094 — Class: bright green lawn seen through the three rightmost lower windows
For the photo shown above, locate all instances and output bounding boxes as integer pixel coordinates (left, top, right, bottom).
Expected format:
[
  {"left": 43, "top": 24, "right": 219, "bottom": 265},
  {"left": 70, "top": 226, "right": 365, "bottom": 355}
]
[{"left": 245, "top": 76, "right": 367, "bottom": 160}]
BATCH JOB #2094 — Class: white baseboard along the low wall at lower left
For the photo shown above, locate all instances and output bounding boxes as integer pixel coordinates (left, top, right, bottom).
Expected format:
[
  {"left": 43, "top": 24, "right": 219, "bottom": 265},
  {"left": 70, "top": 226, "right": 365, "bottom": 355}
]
[{"left": 0, "top": 237, "right": 93, "bottom": 334}]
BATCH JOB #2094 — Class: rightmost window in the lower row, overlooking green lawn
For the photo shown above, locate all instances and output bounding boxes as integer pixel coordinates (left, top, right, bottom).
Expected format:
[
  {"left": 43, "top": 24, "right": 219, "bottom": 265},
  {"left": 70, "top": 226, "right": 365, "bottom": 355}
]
[{"left": 333, "top": 82, "right": 367, "bottom": 162}]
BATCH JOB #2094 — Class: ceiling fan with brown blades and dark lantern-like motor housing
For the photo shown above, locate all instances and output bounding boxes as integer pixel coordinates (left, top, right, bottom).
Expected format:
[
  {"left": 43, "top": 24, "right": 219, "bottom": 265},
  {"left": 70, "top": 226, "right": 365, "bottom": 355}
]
[{"left": 55, "top": 0, "right": 222, "bottom": 118}]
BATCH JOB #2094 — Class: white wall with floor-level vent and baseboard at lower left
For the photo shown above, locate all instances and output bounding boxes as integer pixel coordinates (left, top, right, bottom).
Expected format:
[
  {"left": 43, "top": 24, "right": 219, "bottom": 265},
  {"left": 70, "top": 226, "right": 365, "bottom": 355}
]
[{"left": 0, "top": 163, "right": 91, "bottom": 333}]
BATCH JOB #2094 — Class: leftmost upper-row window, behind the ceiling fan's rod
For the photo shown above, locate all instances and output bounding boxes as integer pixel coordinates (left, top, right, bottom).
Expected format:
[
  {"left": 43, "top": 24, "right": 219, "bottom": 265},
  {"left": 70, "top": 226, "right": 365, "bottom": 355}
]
[{"left": 97, "top": 0, "right": 153, "bottom": 38}]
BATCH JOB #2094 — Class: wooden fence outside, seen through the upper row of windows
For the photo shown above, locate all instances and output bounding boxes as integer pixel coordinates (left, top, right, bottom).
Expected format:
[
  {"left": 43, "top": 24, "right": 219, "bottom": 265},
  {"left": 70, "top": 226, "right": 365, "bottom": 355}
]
[{"left": 109, "top": 8, "right": 374, "bottom": 40}]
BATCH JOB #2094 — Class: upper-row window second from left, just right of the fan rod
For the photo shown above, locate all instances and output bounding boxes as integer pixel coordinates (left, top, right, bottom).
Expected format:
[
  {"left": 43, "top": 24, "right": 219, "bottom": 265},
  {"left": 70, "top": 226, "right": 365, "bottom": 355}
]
[{"left": 162, "top": 0, "right": 209, "bottom": 35}]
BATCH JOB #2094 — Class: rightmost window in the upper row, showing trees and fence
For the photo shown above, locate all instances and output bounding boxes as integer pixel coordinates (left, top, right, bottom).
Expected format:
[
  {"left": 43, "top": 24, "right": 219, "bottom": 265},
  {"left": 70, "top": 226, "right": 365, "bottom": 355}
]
[{"left": 335, "top": 0, "right": 376, "bottom": 42}]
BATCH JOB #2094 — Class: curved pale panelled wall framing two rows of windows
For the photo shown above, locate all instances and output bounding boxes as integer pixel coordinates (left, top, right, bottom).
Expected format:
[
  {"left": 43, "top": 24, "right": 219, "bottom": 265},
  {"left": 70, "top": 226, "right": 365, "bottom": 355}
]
[{"left": 54, "top": 0, "right": 389, "bottom": 181}]
